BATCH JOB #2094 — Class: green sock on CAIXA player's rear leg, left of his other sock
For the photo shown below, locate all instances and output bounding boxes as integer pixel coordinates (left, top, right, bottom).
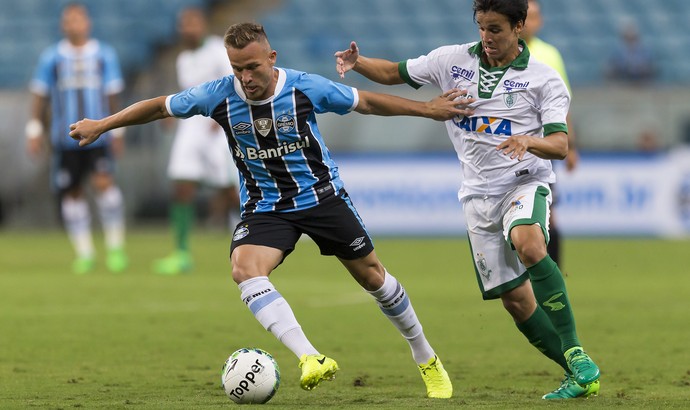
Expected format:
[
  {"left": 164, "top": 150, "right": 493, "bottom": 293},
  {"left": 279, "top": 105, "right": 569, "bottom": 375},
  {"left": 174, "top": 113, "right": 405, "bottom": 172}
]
[{"left": 515, "top": 306, "right": 570, "bottom": 372}]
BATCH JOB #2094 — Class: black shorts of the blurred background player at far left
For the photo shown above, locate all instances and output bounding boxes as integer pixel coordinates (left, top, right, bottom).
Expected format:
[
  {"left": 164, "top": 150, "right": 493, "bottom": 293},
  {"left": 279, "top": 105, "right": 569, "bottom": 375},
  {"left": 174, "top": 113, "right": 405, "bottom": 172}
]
[{"left": 52, "top": 147, "right": 115, "bottom": 194}]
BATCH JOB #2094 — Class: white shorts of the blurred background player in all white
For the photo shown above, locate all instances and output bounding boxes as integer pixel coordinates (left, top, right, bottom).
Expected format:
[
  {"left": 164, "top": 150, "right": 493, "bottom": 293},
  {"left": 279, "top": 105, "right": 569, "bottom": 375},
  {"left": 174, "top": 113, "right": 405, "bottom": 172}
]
[{"left": 168, "top": 116, "right": 239, "bottom": 187}]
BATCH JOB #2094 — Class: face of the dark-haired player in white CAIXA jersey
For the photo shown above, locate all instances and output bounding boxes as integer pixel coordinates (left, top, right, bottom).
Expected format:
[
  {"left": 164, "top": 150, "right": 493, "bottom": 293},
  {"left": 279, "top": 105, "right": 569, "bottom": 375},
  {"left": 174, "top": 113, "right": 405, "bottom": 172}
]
[{"left": 476, "top": 11, "right": 522, "bottom": 67}]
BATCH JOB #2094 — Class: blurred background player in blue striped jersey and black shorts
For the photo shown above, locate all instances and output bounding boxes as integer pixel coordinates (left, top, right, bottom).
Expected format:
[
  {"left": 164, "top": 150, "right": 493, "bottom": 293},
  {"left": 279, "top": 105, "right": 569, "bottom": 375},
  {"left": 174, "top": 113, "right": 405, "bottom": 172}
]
[{"left": 26, "top": 3, "right": 128, "bottom": 274}]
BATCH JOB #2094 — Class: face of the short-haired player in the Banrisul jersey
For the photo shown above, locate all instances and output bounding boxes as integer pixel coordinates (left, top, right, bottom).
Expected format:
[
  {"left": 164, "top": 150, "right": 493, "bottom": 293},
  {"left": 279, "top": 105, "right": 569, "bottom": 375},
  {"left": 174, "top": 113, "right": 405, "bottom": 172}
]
[{"left": 227, "top": 41, "right": 278, "bottom": 101}]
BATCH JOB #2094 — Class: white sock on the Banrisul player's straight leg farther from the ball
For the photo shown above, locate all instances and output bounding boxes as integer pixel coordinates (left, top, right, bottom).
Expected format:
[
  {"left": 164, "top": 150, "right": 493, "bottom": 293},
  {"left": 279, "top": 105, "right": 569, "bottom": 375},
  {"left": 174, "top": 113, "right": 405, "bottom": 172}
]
[{"left": 369, "top": 271, "right": 434, "bottom": 364}]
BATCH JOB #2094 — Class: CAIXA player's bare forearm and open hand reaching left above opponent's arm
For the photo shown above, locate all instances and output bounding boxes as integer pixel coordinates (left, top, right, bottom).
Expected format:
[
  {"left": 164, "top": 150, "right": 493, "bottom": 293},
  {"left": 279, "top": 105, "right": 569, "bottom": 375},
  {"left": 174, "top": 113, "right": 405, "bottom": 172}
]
[{"left": 335, "top": 41, "right": 404, "bottom": 85}]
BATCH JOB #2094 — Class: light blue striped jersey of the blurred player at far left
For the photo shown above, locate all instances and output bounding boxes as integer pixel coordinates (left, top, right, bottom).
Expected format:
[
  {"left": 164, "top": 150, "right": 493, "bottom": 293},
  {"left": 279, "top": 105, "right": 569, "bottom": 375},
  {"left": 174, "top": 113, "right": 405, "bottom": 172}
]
[{"left": 30, "top": 40, "right": 124, "bottom": 150}]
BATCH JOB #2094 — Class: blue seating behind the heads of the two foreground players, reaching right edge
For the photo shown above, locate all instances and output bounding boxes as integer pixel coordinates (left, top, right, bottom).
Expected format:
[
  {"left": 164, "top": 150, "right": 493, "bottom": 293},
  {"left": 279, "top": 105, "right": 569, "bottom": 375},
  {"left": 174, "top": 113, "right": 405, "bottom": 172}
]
[{"left": 254, "top": 0, "right": 690, "bottom": 86}]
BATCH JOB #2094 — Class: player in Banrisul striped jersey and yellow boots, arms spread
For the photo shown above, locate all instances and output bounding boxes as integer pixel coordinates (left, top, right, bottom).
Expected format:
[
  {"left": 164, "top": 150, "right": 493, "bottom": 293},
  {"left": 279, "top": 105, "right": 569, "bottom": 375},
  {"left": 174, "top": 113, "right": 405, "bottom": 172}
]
[{"left": 70, "top": 23, "right": 474, "bottom": 398}]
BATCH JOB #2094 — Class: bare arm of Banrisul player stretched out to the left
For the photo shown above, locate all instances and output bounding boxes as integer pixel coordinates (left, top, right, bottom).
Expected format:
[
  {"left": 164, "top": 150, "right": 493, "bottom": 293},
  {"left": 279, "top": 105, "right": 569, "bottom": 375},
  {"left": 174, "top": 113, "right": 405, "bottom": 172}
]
[{"left": 69, "top": 96, "right": 170, "bottom": 147}]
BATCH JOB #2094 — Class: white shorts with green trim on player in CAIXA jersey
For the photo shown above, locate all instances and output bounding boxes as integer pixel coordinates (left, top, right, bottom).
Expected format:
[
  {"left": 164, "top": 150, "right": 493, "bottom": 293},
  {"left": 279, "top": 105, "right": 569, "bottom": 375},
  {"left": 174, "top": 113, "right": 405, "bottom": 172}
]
[{"left": 462, "top": 184, "right": 551, "bottom": 299}]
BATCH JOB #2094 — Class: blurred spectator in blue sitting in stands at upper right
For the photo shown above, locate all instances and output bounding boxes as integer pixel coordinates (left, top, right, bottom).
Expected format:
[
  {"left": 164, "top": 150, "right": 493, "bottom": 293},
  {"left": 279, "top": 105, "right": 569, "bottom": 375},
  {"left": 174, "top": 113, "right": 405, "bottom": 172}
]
[{"left": 606, "top": 22, "right": 657, "bottom": 84}]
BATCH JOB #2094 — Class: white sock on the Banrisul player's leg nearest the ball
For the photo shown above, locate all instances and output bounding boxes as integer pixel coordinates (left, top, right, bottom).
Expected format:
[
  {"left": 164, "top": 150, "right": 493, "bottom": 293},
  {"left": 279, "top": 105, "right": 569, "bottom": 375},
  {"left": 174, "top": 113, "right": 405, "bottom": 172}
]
[{"left": 239, "top": 276, "right": 319, "bottom": 357}]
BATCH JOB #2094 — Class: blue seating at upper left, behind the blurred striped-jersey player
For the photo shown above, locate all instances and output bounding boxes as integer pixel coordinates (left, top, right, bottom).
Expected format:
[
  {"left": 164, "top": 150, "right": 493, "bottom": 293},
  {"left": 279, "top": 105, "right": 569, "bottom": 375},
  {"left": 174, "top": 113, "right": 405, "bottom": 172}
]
[{"left": 0, "top": 0, "right": 213, "bottom": 89}]
